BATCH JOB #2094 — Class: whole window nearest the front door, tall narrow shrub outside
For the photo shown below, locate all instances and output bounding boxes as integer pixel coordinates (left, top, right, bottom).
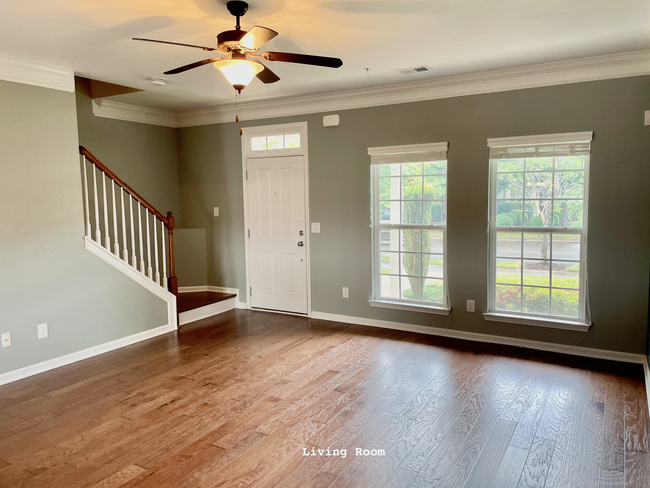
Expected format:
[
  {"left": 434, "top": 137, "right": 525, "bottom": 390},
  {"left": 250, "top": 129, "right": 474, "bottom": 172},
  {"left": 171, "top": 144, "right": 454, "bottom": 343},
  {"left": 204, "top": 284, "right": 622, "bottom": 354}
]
[{"left": 368, "top": 143, "right": 448, "bottom": 313}]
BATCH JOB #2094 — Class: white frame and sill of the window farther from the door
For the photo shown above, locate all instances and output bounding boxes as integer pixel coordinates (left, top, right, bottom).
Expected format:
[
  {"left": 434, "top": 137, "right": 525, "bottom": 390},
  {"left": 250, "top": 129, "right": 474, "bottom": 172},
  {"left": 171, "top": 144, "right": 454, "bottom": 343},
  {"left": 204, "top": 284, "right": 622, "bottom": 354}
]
[{"left": 483, "top": 132, "right": 593, "bottom": 331}]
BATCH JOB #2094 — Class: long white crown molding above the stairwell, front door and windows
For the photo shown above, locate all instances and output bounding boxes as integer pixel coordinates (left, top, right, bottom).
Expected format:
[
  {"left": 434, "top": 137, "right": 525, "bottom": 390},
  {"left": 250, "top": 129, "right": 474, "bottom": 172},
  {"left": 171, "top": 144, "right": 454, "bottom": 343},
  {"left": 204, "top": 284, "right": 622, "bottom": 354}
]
[{"left": 86, "top": 50, "right": 650, "bottom": 127}]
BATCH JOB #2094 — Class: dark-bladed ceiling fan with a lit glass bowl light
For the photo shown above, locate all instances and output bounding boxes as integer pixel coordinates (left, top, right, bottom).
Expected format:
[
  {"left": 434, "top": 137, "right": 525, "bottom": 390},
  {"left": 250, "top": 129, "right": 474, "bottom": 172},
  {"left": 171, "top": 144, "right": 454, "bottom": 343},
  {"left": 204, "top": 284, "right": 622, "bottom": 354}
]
[{"left": 133, "top": 1, "right": 343, "bottom": 93}]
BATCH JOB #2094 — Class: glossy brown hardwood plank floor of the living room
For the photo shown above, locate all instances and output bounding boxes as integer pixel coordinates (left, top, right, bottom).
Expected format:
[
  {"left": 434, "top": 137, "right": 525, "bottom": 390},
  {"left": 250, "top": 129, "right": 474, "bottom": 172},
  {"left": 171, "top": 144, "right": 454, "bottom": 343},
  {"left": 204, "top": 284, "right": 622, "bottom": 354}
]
[{"left": 0, "top": 310, "right": 650, "bottom": 488}]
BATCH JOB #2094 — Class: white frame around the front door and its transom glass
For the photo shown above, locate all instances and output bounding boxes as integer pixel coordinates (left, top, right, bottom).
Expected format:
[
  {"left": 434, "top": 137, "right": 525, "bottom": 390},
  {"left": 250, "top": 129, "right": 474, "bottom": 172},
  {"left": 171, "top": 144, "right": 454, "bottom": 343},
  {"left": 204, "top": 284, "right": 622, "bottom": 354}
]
[{"left": 241, "top": 121, "right": 311, "bottom": 317}]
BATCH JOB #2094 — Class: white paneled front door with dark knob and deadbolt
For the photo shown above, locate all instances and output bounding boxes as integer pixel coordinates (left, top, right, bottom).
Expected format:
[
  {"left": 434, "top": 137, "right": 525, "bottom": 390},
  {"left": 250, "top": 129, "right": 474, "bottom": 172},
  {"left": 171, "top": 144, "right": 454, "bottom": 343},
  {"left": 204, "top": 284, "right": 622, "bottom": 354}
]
[{"left": 247, "top": 156, "right": 307, "bottom": 314}]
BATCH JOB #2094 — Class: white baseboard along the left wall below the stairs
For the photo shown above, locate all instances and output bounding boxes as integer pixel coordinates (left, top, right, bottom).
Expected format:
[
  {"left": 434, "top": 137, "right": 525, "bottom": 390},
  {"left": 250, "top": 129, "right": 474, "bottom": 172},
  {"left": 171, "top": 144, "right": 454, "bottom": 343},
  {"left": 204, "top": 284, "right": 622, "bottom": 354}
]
[{"left": 0, "top": 325, "right": 177, "bottom": 385}]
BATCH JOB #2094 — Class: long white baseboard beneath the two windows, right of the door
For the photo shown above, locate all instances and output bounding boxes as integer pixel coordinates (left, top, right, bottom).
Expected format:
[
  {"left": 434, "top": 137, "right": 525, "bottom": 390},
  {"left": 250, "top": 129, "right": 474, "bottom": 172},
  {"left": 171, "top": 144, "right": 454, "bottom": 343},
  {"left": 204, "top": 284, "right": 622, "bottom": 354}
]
[{"left": 311, "top": 312, "right": 647, "bottom": 364}]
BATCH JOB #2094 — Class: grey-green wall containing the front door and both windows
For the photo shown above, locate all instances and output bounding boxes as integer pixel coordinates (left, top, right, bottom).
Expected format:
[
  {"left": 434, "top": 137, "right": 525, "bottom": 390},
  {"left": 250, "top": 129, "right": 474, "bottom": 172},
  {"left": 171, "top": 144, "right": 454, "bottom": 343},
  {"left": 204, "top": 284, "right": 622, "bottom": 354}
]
[{"left": 178, "top": 76, "right": 650, "bottom": 353}]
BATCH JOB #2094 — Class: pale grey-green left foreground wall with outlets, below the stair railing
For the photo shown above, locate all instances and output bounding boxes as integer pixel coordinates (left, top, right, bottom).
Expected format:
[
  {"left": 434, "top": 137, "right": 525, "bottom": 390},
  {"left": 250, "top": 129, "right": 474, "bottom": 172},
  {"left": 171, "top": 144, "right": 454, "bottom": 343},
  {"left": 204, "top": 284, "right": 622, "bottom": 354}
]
[{"left": 0, "top": 81, "right": 168, "bottom": 374}]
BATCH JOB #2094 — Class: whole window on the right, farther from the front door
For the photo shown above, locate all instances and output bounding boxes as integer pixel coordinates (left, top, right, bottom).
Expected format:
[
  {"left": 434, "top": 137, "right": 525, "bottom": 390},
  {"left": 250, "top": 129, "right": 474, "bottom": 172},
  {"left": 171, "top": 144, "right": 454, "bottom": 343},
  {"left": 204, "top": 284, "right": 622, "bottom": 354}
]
[{"left": 486, "top": 132, "right": 592, "bottom": 323}]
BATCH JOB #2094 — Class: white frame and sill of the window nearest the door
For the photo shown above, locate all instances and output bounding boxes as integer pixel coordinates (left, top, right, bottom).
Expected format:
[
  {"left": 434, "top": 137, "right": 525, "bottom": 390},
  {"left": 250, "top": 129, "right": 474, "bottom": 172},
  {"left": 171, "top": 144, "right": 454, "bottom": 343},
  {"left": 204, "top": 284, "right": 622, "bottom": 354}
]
[{"left": 368, "top": 142, "right": 451, "bottom": 315}]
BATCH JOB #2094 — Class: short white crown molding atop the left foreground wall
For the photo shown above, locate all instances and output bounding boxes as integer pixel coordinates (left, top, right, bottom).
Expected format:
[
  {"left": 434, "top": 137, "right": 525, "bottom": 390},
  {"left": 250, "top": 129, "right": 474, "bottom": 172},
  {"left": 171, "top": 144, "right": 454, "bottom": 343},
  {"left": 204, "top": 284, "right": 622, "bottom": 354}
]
[{"left": 0, "top": 54, "right": 74, "bottom": 92}]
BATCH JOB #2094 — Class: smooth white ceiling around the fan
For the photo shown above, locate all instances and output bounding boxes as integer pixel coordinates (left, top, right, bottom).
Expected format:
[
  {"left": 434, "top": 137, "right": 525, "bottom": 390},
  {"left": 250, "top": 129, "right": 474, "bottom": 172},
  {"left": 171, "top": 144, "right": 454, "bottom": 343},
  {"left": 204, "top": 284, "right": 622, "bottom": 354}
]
[{"left": 0, "top": 0, "right": 650, "bottom": 112}]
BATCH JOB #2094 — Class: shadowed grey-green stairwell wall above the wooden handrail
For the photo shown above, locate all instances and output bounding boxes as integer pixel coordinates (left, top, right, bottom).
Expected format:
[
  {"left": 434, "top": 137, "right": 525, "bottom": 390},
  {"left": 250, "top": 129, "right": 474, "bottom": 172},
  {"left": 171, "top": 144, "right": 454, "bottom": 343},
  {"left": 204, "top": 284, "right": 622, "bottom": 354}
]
[{"left": 76, "top": 82, "right": 182, "bottom": 227}]
